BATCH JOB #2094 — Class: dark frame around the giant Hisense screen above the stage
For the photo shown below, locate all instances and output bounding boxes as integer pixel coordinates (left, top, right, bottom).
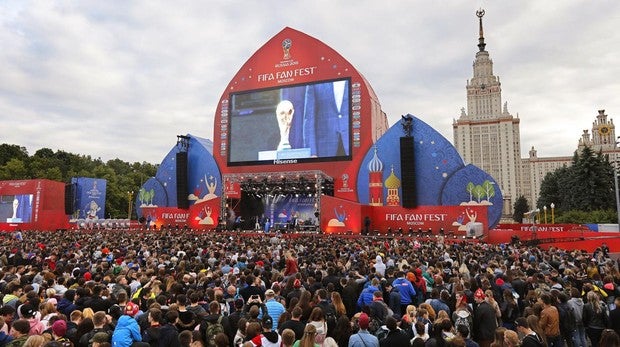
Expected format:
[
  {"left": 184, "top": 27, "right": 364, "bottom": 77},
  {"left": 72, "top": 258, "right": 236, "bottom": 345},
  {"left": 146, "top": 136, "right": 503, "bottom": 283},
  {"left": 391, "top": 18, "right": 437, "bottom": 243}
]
[{"left": 221, "top": 76, "right": 353, "bottom": 167}]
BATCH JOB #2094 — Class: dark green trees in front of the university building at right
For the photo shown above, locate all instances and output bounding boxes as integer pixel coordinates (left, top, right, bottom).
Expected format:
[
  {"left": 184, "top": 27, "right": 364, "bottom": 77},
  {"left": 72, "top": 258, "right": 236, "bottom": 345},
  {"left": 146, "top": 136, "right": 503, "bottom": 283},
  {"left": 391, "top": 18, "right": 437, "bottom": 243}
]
[{"left": 513, "top": 147, "right": 620, "bottom": 224}]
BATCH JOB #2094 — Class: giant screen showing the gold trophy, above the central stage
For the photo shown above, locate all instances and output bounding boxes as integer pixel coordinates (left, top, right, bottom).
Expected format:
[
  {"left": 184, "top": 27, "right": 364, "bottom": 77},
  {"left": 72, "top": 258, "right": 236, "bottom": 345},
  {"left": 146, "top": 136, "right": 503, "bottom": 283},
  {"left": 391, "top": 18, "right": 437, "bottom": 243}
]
[{"left": 229, "top": 78, "right": 351, "bottom": 166}]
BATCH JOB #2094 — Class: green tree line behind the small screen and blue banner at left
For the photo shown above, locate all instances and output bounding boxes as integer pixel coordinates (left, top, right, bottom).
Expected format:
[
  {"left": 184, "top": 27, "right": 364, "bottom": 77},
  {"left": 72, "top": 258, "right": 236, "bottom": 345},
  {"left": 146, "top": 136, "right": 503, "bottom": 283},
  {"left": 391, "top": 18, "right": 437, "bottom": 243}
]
[{"left": 0, "top": 143, "right": 158, "bottom": 218}]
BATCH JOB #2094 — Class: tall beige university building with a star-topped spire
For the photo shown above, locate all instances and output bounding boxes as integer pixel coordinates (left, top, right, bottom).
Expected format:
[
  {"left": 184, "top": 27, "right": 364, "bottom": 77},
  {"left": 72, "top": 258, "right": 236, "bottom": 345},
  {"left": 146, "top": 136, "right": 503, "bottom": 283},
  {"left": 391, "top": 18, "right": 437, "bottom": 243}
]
[{"left": 452, "top": 10, "right": 620, "bottom": 216}]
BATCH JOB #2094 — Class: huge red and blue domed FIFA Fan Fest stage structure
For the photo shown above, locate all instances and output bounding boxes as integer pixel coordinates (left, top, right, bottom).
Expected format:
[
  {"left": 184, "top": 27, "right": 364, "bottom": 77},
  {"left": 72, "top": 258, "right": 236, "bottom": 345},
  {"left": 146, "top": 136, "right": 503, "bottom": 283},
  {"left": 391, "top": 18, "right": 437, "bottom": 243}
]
[{"left": 136, "top": 28, "right": 502, "bottom": 236}]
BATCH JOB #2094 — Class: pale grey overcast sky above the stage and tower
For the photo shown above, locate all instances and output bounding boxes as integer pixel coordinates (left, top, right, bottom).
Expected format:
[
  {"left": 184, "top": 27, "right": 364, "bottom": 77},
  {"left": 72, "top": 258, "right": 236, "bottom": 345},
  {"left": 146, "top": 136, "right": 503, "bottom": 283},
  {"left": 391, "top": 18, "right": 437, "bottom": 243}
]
[{"left": 0, "top": 0, "right": 620, "bottom": 163}]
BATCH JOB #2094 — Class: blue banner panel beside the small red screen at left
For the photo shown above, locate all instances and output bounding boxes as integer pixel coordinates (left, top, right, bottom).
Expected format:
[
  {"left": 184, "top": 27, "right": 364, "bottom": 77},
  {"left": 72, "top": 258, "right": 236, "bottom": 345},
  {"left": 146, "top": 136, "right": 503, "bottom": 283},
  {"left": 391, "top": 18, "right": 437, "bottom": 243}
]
[{"left": 71, "top": 177, "right": 107, "bottom": 222}]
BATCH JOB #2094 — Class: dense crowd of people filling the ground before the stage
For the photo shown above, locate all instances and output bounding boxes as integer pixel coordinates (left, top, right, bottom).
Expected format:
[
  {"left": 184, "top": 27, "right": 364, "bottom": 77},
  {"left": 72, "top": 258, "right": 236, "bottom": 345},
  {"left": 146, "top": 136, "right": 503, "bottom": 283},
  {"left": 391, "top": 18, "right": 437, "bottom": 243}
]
[{"left": 0, "top": 230, "right": 620, "bottom": 347}]
